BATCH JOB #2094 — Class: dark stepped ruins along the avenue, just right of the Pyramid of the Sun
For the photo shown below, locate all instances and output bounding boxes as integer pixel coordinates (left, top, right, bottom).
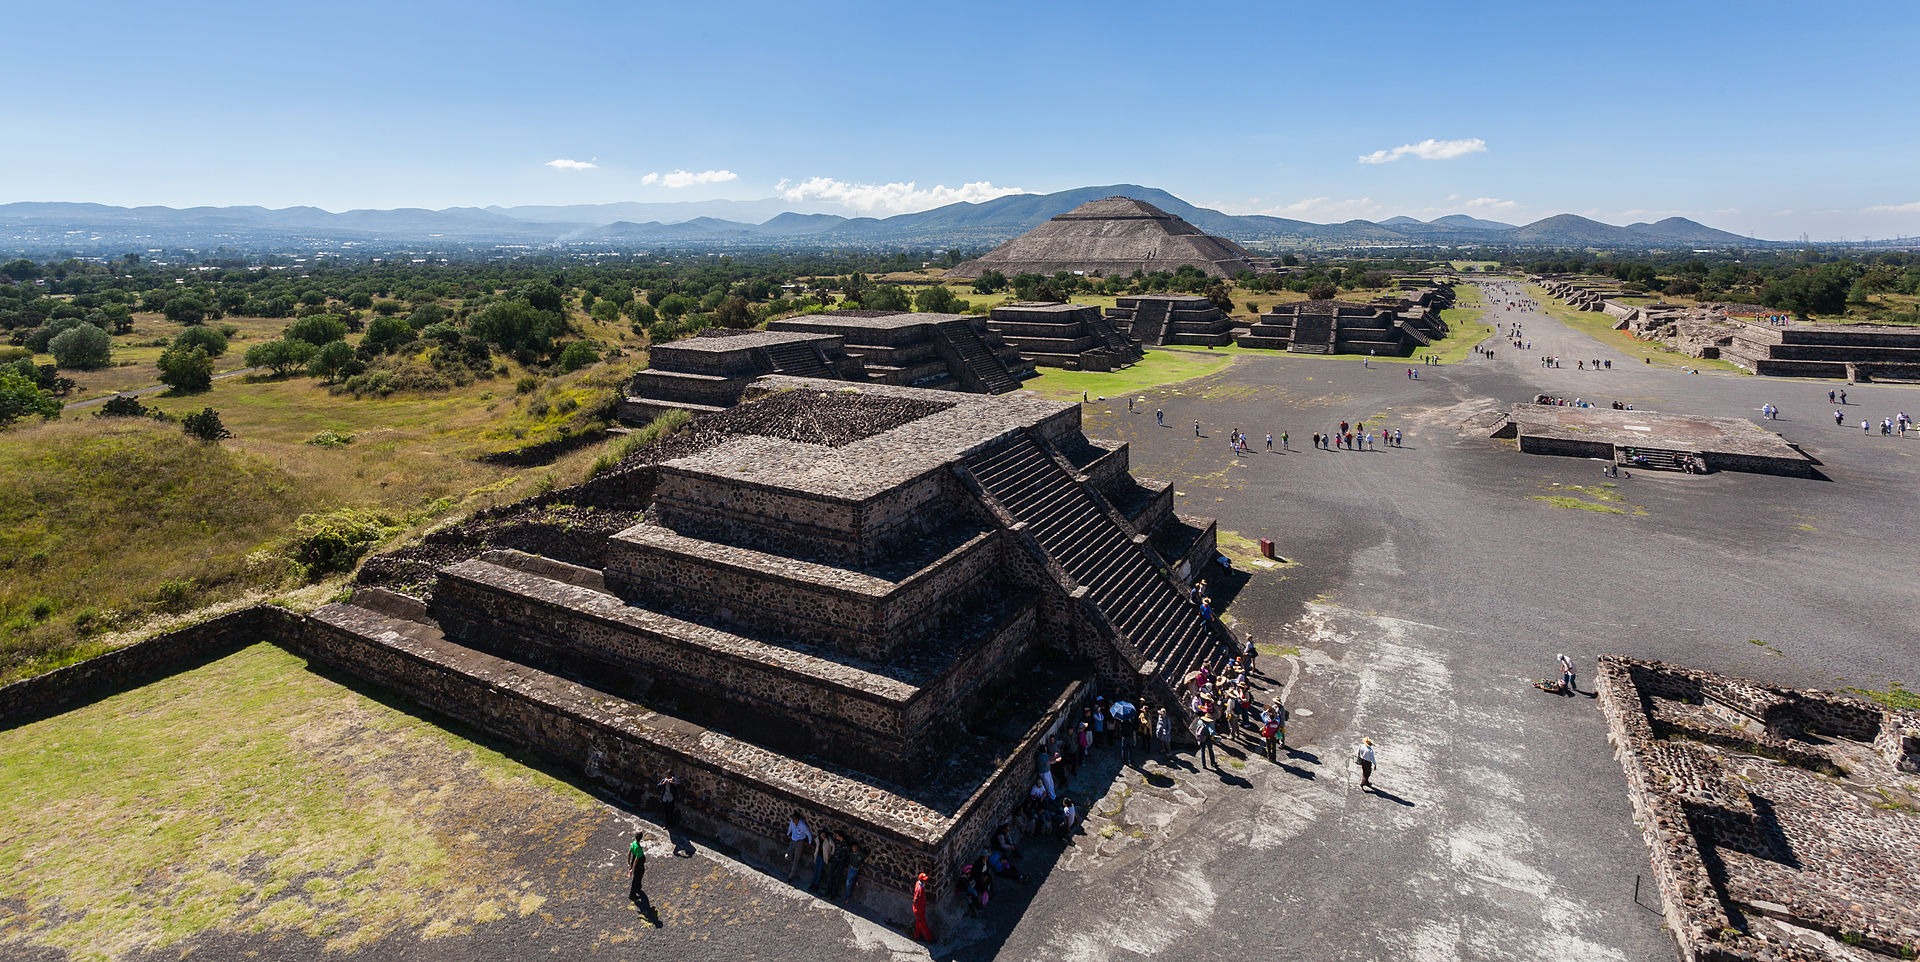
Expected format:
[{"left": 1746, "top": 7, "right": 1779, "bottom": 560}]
[{"left": 1238, "top": 284, "right": 1453, "bottom": 357}]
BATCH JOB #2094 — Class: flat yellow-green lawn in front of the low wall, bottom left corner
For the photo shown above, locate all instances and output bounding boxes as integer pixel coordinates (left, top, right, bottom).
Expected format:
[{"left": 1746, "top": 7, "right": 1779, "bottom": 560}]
[{"left": 0, "top": 645, "right": 595, "bottom": 960}]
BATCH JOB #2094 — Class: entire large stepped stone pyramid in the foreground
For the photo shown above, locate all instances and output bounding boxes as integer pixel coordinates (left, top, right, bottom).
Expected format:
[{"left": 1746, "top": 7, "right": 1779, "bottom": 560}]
[{"left": 312, "top": 376, "right": 1233, "bottom": 912}]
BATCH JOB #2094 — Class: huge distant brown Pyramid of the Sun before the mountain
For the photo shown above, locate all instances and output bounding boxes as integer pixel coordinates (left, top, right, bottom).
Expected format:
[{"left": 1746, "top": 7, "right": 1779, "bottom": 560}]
[{"left": 947, "top": 198, "right": 1254, "bottom": 277}]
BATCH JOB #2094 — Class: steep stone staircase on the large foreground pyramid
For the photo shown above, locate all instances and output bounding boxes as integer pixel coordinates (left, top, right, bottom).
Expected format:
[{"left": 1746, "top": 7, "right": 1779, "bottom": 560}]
[{"left": 962, "top": 434, "right": 1229, "bottom": 687}]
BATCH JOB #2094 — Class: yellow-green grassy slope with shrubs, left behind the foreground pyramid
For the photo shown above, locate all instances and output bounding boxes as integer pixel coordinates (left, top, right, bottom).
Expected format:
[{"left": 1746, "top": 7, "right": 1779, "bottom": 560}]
[{"left": 0, "top": 337, "right": 639, "bottom": 682}]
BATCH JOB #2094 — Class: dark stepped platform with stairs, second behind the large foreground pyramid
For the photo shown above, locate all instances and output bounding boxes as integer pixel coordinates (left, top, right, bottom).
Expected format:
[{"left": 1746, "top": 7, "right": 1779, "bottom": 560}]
[{"left": 766, "top": 311, "right": 1035, "bottom": 394}]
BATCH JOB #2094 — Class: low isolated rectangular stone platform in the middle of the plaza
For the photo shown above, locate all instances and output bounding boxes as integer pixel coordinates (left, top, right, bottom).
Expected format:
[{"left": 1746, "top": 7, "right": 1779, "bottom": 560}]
[{"left": 1494, "top": 403, "right": 1814, "bottom": 478}]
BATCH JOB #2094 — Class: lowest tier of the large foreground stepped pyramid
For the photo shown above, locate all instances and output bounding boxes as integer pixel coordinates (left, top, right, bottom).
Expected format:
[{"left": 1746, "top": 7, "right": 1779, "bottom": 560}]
[{"left": 286, "top": 605, "right": 1085, "bottom": 916}]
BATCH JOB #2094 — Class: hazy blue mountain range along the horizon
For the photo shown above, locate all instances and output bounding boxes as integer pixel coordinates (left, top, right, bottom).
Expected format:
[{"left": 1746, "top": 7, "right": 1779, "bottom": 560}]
[{"left": 0, "top": 184, "right": 1770, "bottom": 253}]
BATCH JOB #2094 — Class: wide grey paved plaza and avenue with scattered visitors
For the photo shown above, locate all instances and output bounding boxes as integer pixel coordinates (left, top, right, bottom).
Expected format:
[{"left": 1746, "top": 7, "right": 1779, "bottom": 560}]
[{"left": 48, "top": 286, "right": 1920, "bottom": 962}]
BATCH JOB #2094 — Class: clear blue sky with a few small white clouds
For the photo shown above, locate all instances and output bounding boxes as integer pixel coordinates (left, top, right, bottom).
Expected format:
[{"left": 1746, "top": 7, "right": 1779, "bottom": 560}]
[{"left": 0, "top": 0, "right": 1920, "bottom": 238}]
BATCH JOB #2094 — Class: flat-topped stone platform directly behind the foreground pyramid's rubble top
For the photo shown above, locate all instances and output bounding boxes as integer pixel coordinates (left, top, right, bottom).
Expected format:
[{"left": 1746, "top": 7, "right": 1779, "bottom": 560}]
[{"left": 620, "top": 328, "right": 866, "bottom": 424}]
